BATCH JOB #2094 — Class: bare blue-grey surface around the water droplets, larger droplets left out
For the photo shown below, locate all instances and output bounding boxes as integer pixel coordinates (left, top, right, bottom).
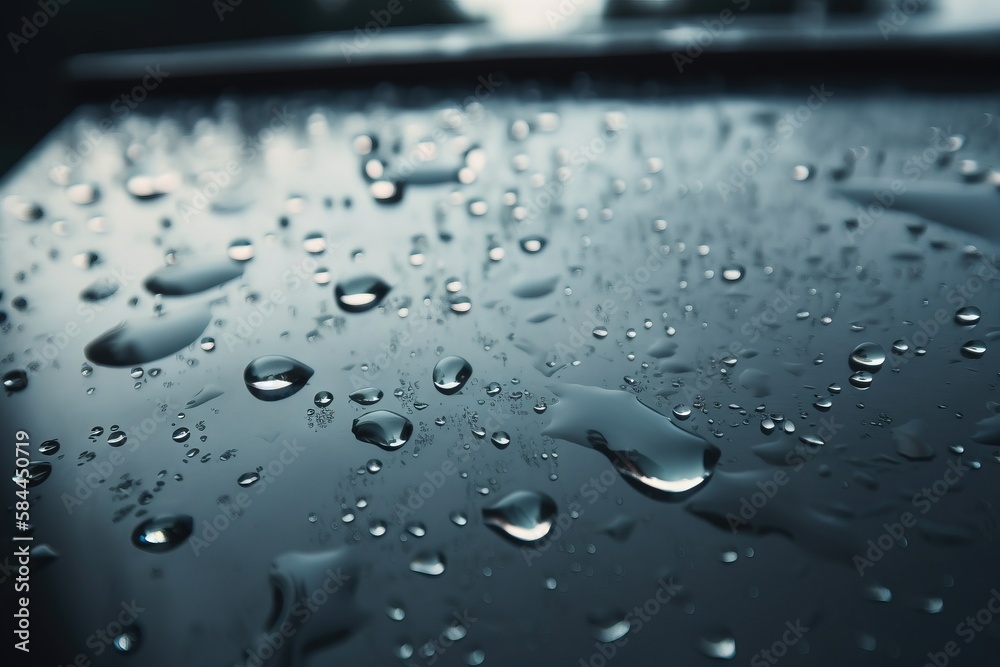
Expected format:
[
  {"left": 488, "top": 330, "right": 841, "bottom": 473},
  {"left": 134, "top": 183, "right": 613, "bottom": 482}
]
[{"left": 0, "top": 85, "right": 1000, "bottom": 665}]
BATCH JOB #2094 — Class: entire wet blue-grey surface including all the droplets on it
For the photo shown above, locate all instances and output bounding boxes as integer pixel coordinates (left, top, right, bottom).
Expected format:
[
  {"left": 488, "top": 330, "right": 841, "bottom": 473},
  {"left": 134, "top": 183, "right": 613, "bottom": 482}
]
[{"left": 0, "top": 85, "right": 1000, "bottom": 667}]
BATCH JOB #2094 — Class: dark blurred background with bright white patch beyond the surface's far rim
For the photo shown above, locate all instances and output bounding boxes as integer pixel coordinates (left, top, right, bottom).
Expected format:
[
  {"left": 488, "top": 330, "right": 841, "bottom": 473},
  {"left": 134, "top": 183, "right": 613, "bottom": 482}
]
[{"left": 0, "top": 0, "right": 1000, "bottom": 173}]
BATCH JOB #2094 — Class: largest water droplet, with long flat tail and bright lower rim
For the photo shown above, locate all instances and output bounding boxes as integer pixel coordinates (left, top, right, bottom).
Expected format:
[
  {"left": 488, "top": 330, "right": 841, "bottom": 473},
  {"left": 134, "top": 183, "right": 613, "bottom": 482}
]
[{"left": 543, "top": 384, "right": 720, "bottom": 497}]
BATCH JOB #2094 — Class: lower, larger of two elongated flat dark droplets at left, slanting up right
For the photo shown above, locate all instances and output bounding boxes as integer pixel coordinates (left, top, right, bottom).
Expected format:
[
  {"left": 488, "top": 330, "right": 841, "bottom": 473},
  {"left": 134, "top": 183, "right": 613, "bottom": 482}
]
[{"left": 83, "top": 306, "right": 212, "bottom": 366}]
